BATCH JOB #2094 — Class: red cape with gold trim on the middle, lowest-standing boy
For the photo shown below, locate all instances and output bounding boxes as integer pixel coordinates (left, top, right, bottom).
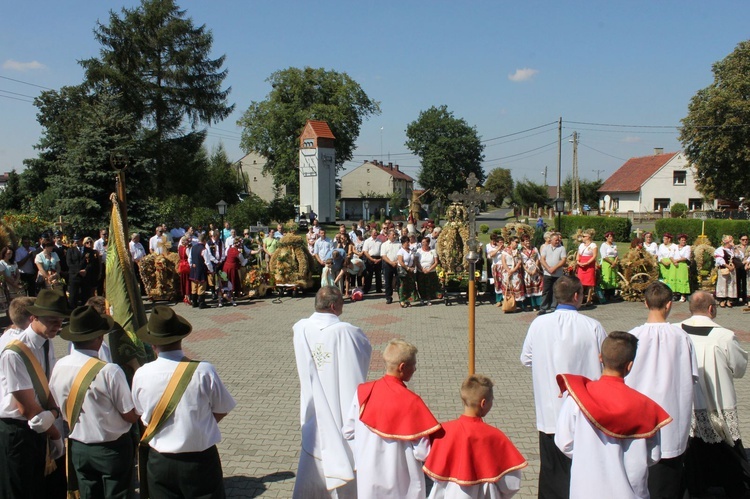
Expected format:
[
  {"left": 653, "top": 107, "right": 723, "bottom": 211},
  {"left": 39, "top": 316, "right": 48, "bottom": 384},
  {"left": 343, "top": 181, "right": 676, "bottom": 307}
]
[{"left": 422, "top": 416, "right": 528, "bottom": 486}]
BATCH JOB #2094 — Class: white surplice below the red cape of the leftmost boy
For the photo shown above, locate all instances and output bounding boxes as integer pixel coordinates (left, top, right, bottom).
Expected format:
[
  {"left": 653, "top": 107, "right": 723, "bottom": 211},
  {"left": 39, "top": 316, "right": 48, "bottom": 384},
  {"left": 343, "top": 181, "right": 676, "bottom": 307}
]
[{"left": 343, "top": 394, "right": 430, "bottom": 499}]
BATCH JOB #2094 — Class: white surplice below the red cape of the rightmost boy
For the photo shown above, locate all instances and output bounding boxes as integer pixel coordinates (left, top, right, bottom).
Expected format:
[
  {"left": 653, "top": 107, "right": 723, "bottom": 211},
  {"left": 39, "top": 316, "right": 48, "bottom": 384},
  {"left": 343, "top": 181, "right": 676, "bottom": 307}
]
[{"left": 555, "top": 394, "right": 670, "bottom": 499}]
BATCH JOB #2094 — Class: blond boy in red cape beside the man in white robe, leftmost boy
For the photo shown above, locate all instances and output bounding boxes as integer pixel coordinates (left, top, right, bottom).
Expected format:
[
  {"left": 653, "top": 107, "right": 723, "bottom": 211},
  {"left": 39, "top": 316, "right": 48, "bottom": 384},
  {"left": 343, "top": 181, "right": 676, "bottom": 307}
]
[{"left": 342, "top": 340, "right": 440, "bottom": 499}]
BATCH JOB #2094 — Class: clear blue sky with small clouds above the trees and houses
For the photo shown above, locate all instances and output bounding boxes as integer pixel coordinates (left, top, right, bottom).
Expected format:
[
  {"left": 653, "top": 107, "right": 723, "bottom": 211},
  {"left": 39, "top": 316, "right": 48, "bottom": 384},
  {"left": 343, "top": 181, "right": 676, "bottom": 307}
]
[{"left": 0, "top": 0, "right": 750, "bottom": 189}]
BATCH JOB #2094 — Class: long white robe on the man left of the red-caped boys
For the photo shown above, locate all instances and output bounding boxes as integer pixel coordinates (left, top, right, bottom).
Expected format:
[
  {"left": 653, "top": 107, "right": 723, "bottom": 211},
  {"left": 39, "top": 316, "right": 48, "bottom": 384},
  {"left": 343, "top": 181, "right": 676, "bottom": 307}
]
[{"left": 293, "top": 312, "right": 372, "bottom": 499}]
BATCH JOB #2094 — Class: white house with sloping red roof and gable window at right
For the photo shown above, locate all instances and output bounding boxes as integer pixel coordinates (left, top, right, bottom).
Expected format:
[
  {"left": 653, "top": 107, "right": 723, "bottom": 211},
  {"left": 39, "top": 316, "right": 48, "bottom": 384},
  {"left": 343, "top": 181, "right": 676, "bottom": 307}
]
[{"left": 598, "top": 149, "right": 715, "bottom": 213}]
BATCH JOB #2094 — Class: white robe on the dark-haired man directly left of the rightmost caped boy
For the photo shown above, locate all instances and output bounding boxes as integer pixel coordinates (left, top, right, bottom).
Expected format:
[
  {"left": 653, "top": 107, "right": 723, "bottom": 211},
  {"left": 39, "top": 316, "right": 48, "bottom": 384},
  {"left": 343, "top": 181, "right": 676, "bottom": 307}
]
[{"left": 521, "top": 305, "right": 607, "bottom": 434}]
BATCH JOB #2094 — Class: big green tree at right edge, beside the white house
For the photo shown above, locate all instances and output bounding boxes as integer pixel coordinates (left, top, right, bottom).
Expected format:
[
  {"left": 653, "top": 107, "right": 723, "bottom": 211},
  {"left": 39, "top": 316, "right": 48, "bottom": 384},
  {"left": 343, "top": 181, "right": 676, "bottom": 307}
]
[{"left": 680, "top": 40, "right": 750, "bottom": 199}]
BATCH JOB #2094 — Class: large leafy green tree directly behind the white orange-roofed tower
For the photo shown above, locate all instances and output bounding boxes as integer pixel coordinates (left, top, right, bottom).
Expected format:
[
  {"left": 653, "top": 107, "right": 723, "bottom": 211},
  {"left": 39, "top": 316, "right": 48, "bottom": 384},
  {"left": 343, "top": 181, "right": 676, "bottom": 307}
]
[{"left": 237, "top": 67, "right": 380, "bottom": 194}]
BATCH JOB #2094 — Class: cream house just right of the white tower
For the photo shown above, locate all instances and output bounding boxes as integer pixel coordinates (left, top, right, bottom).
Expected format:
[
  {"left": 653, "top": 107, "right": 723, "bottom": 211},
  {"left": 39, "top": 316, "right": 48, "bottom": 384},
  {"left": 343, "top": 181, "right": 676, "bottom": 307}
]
[{"left": 340, "top": 160, "right": 414, "bottom": 220}]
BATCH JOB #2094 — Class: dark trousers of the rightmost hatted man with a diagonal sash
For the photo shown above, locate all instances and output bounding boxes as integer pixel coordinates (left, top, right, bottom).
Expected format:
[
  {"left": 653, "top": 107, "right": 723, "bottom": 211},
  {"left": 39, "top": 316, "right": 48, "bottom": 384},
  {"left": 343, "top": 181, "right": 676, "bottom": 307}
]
[{"left": 148, "top": 445, "right": 226, "bottom": 499}]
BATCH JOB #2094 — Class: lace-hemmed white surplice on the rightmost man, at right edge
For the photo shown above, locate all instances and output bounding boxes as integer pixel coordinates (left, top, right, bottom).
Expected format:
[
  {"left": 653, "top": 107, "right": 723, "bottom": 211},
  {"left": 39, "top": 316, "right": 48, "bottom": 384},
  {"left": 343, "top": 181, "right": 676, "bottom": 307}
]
[{"left": 681, "top": 315, "right": 747, "bottom": 446}]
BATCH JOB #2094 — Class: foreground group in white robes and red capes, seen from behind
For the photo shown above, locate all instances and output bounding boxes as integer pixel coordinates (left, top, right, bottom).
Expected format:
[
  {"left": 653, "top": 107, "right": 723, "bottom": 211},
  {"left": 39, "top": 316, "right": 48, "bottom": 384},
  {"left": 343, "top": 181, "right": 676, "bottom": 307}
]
[{"left": 293, "top": 282, "right": 750, "bottom": 499}]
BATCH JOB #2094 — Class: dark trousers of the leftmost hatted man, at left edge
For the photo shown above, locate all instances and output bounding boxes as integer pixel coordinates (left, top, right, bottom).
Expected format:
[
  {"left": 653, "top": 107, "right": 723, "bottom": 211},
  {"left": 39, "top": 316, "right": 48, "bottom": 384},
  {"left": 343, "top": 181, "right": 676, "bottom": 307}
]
[{"left": 0, "top": 418, "right": 48, "bottom": 499}]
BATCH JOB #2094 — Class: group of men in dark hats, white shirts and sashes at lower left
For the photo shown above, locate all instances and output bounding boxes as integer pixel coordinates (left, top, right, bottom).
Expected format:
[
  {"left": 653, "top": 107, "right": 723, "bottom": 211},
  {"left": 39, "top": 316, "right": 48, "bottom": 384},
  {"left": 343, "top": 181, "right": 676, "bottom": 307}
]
[{"left": 0, "top": 289, "right": 235, "bottom": 499}]
